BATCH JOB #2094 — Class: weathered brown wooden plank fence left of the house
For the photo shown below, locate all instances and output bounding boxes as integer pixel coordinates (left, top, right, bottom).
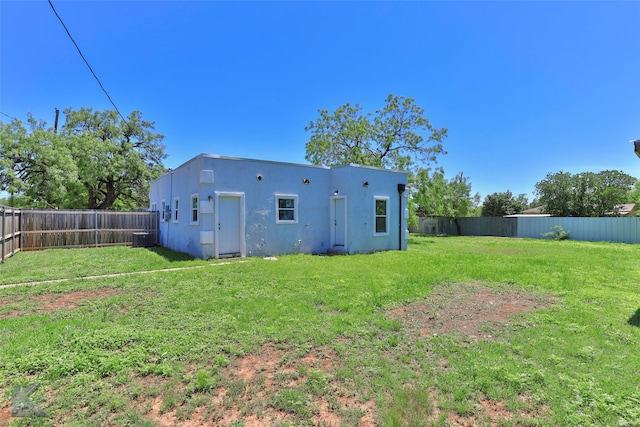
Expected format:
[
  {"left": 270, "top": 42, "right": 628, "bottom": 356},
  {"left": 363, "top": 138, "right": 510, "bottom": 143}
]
[{"left": 0, "top": 206, "right": 159, "bottom": 261}]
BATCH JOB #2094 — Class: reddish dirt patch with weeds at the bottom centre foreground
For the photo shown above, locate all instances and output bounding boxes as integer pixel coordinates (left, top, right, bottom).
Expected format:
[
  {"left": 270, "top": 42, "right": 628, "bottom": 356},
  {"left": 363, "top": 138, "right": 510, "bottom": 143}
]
[{"left": 135, "top": 343, "right": 375, "bottom": 427}]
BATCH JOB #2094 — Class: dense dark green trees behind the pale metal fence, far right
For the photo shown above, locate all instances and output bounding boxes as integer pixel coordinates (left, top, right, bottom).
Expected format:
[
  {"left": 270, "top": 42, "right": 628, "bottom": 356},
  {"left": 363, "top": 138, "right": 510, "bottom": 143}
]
[{"left": 535, "top": 170, "right": 637, "bottom": 217}]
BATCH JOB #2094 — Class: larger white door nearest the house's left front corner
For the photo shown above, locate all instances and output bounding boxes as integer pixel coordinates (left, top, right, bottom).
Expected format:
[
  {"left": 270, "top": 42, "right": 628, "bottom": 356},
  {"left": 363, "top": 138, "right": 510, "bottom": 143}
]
[{"left": 216, "top": 195, "right": 242, "bottom": 255}]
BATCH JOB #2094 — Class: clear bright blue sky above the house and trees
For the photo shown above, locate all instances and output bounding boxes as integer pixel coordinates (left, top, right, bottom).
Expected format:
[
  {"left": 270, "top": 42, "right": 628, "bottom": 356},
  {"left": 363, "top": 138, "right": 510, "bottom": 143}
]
[{"left": 0, "top": 0, "right": 640, "bottom": 198}]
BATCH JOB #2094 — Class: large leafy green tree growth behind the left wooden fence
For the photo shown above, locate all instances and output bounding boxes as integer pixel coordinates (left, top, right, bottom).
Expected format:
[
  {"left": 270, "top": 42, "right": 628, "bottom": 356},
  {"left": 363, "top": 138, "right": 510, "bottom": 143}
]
[{"left": 0, "top": 108, "right": 166, "bottom": 209}]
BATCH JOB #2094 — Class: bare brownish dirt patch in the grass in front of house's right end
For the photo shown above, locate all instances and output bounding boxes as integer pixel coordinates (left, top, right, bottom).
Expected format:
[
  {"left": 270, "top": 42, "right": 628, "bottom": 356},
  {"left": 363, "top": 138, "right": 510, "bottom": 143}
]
[{"left": 389, "top": 283, "right": 557, "bottom": 341}]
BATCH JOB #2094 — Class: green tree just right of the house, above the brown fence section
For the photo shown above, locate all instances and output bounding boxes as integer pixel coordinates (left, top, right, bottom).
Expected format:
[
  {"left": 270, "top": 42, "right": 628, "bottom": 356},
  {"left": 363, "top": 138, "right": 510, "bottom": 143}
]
[{"left": 410, "top": 168, "right": 480, "bottom": 218}]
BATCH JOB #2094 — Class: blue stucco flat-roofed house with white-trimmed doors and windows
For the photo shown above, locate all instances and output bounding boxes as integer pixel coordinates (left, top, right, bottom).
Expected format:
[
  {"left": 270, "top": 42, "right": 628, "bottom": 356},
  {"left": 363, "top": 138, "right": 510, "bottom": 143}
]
[{"left": 150, "top": 154, "right": 408, "bottom": 258}]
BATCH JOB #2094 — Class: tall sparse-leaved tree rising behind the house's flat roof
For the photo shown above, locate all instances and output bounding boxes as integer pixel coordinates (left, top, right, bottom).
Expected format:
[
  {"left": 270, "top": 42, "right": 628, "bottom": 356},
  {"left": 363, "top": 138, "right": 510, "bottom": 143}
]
[{"left": 305, "top": 95, "right": 447, "bottom": 170}]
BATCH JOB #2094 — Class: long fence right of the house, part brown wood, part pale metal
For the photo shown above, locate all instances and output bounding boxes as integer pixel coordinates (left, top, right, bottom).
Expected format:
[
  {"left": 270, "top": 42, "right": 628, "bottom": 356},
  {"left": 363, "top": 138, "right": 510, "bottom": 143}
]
[{"left": 415, "top": 216, "right": 640, "bottom": 243}]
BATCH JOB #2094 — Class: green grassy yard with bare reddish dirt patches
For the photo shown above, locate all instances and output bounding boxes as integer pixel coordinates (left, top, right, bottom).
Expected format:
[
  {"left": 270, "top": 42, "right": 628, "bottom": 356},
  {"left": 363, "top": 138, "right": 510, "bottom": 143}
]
[{"left": 0, "top": 236, "right": 640, "bottom": 427}]
